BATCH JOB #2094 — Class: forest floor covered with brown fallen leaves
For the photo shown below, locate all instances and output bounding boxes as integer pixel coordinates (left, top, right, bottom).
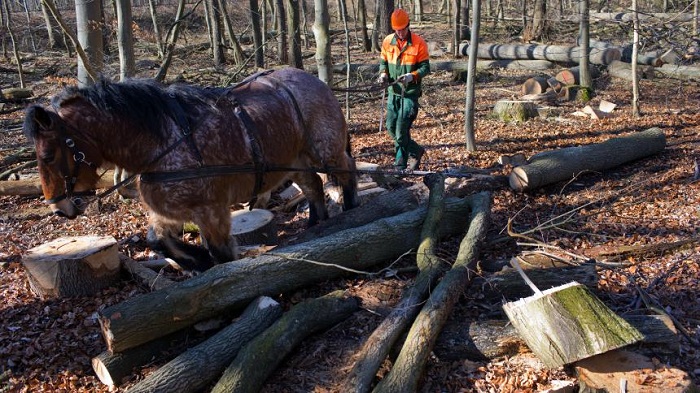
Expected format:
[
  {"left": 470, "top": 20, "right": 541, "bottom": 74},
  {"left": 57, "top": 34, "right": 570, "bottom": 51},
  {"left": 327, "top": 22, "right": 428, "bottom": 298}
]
[{"left": 0, "top": 12, "right": 700, "bottom": 392}]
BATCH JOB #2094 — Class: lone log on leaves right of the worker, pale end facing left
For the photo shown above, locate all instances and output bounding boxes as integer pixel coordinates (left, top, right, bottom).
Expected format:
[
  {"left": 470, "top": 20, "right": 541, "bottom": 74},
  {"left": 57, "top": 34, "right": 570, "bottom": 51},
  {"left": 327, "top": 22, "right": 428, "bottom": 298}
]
[{"left": 509, "top": 127, "right": 666, "bottom": 191}]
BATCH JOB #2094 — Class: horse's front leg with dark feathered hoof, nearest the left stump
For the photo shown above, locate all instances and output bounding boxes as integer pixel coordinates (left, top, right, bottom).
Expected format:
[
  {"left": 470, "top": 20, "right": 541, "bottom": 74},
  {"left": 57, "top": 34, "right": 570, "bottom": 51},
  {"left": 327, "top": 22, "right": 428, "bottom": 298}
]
[{"left": 146, "top": 212, "right": 214, "bottom": 271}]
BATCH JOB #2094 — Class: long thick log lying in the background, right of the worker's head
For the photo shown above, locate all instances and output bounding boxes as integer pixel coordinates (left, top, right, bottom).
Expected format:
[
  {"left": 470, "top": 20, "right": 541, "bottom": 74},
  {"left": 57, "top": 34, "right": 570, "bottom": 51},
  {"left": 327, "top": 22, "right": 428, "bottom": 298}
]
[{"left": 460, "top": 43, "right": 622, "bottom": 65}]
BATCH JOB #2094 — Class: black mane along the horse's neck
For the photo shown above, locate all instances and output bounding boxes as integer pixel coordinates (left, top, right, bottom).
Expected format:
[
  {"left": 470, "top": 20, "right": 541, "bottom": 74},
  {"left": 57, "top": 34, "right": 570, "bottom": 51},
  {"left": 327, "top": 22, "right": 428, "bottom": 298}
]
[{"left": 51, "top": 78, "right": 230, "bottom": 139}]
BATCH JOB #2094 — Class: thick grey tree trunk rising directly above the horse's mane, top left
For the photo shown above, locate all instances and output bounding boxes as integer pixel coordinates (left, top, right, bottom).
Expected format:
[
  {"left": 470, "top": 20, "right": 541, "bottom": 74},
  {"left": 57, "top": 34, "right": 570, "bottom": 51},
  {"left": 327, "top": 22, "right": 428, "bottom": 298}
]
[{"left": 75, "top": 0, "right": 104, "bottom": 87}]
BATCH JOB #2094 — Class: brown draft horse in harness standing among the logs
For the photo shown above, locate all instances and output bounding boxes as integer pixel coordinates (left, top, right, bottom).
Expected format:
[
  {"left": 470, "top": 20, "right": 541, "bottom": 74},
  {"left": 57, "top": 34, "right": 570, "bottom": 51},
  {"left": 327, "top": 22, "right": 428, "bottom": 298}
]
[{"left": 24, "top": 68, "right": 357, "bottom": 270}]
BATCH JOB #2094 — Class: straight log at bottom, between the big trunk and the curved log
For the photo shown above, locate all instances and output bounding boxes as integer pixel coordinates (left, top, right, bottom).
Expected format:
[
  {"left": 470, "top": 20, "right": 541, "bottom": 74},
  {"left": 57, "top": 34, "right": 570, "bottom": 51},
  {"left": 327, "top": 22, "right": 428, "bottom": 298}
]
[{"left": 129, "top": 296, "right": 282, "bottom": 393}]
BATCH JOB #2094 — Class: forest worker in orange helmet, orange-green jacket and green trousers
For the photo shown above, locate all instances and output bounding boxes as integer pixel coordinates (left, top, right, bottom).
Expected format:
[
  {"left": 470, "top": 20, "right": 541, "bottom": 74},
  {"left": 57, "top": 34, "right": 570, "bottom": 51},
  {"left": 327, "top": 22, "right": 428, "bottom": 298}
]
[{"left": 377, "top": 8, "right": 430, "bottom": 170}]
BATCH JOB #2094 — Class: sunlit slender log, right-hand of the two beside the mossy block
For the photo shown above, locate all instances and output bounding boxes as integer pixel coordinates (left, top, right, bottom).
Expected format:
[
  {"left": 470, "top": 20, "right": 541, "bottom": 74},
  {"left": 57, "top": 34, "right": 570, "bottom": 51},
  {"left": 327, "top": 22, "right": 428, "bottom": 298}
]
[{"left": 374, "top": 192, "right": 491, "bottom": 392}]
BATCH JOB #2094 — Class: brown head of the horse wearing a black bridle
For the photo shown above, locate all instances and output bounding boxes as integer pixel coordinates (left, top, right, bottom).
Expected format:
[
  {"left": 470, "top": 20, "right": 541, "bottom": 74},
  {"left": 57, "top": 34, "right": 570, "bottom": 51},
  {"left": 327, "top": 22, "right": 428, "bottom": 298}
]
[{"left": 23, "top": 105, "right": 99, "bottom": 219}]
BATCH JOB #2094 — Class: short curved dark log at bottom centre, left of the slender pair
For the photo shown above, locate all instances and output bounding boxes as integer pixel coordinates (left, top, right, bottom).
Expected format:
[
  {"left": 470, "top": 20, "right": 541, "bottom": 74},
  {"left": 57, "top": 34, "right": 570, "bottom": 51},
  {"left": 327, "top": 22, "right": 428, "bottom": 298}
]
[{"left": 212, "top": 291, "right": 359, "bottom": 393}]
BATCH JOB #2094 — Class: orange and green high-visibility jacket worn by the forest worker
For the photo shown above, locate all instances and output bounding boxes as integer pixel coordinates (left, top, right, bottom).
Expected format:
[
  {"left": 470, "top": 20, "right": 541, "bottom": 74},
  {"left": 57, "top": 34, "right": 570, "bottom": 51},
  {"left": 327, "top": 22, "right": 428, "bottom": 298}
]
[{"left": 379, "top": 32, "right": 430, "bottom": 97}]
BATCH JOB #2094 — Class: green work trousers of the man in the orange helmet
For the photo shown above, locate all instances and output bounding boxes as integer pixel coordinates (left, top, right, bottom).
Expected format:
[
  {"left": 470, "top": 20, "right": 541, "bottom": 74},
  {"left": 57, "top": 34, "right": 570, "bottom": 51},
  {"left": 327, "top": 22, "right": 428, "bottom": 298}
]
[{"left": 386, "top": 93, "right": 423, "bottom": 169}]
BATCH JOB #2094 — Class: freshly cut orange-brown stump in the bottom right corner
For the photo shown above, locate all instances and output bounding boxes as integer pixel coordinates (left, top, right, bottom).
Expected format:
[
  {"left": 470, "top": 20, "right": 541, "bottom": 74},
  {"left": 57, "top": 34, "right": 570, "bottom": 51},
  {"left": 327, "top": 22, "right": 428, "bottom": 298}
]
[{"left": 576, "top": 350, "right": 700, "bottom": 393}]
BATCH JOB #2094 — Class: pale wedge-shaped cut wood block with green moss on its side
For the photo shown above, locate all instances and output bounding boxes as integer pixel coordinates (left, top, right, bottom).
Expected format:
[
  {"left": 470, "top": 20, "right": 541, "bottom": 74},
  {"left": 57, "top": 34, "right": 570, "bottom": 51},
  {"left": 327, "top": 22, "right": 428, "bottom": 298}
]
[{"left": 503, "top": 282, "right": 644, "bottom": 368}]
